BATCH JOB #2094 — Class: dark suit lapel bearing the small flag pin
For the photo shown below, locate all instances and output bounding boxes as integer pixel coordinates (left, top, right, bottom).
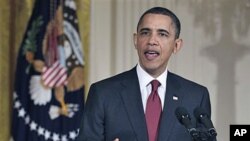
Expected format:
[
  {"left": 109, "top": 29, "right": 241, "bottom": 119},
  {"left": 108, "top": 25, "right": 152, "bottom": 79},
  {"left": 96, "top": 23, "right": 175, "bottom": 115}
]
[{"left": 158, "top": 72, "right": 181, "bottom": 141}]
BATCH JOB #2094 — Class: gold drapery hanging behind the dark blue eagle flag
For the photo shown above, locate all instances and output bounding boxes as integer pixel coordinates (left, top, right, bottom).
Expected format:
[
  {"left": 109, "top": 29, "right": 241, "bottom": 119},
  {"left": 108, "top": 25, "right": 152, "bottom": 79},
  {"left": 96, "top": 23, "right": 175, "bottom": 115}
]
[{"left": 0, "top": 0, "right": 90, "bottom": 141}]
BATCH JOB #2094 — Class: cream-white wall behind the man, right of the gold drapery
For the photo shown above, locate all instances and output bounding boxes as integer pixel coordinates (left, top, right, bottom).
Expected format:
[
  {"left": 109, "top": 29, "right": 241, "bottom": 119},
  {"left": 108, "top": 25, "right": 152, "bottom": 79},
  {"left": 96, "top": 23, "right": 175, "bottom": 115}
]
[{"left": 89, "top": 0, "right": 250, "bottom": 141}]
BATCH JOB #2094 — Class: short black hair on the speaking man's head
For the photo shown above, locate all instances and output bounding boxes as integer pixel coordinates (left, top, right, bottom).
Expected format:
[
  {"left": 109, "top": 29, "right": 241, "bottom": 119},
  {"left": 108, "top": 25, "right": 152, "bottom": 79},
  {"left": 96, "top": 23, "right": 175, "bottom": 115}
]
[{"left": 137, "top": 7, "right": 181, "bottom": 39}]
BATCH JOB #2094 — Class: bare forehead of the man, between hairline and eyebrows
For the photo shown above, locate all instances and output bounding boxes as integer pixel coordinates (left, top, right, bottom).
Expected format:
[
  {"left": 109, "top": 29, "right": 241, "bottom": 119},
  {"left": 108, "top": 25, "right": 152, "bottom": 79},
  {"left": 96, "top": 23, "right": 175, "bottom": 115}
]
[{"left": 139, "top": 13, "right": 174, "bottom": 31}]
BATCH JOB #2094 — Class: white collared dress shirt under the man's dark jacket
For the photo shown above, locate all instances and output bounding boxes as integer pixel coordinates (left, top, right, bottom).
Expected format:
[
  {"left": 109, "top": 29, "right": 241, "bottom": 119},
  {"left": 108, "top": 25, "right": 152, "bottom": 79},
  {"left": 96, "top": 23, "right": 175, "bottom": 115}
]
[{"left": 136, "top": 63, "right": 168, "bottom": 113}]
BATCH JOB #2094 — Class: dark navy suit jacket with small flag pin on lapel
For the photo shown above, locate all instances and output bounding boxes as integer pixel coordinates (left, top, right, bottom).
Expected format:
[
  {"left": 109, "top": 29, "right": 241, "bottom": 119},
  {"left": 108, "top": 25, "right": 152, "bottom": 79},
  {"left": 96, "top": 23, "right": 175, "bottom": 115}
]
[{"left": 78, "top": 68, "right": 213, "bottom": 141}]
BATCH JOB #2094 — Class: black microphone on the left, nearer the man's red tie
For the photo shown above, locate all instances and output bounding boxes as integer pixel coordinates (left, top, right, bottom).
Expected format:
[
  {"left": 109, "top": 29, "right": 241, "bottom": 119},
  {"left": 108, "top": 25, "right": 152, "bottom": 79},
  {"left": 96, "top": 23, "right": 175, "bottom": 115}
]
[{"left": 175, "top": 107, "right": 199, "bottom": 139}]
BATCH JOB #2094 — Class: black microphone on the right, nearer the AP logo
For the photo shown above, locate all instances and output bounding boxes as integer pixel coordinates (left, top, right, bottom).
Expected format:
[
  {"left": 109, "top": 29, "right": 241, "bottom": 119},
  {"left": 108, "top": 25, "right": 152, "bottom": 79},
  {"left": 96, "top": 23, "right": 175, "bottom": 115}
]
[{"left": 194, "top": 107, "right": 217, "bottom": 137}]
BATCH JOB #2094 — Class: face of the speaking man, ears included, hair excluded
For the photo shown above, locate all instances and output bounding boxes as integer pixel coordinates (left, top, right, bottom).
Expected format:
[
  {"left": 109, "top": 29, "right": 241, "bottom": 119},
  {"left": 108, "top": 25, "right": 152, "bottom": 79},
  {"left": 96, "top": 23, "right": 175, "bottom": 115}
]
[{"left": 134, "top": 14, "right": 182, "bottom": 77}]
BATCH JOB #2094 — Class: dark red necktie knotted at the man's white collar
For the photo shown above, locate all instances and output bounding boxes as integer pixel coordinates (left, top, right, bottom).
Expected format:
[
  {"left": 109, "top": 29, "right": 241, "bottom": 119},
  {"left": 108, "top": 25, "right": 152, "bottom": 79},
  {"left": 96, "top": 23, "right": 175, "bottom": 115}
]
[{"left": 146, "top": 80, "right": 162, "bottom": 141}]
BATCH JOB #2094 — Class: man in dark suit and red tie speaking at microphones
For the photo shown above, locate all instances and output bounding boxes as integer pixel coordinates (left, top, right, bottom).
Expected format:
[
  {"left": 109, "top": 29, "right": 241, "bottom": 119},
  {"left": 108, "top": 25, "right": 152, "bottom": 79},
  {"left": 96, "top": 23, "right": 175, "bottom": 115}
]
[{"left": 78, "top": 7, "right": 214, "bottom": 141}]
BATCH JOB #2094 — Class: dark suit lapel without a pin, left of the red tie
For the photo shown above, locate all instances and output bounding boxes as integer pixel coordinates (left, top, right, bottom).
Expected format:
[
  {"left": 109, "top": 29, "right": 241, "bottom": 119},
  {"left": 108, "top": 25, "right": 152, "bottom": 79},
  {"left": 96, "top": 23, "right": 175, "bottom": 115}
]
[{"left": 121, "top": 68, "right": 148, "bottom": 141}]
